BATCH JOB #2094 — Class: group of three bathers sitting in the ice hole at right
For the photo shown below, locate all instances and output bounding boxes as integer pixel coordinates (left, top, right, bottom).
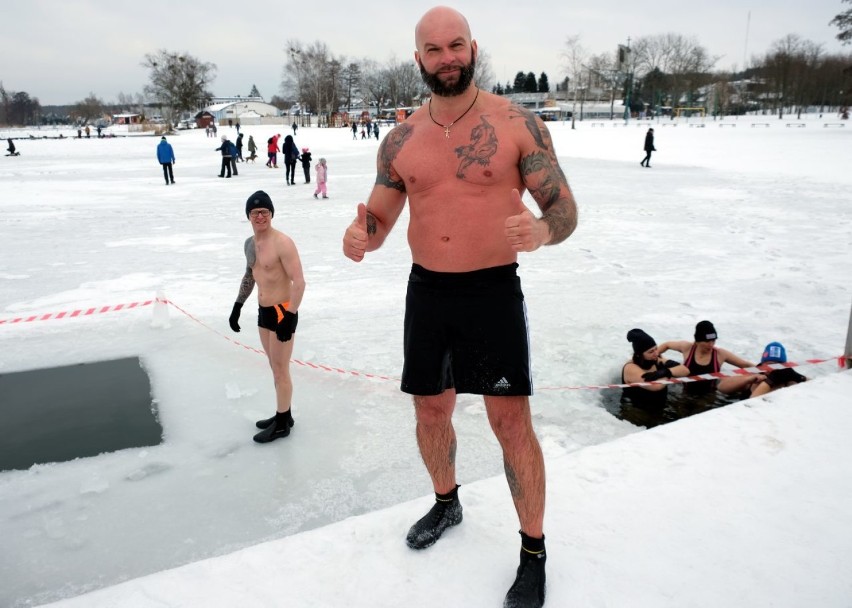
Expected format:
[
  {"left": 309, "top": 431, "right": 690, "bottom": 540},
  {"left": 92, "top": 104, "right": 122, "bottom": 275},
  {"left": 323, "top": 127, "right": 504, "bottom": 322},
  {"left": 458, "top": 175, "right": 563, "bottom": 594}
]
[{"left": 621, "top": 321, "right": 806, "bottom": 411}]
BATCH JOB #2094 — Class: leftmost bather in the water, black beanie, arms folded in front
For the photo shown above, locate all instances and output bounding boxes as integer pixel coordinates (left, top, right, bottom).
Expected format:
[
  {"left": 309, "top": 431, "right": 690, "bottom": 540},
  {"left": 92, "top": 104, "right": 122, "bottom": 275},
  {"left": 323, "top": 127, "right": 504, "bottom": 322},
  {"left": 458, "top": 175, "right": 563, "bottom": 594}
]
[{"left": 621, "top": 328, "right": 689, "bottom": 412}]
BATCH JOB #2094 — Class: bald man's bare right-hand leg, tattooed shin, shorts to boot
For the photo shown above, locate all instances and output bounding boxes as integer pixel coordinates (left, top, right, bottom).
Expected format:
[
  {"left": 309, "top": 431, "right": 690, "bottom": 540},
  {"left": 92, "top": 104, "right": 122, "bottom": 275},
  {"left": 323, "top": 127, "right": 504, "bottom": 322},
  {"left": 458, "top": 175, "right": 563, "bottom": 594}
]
[{"left": 485, "top": 396, "right": 545, "bottom": 538}]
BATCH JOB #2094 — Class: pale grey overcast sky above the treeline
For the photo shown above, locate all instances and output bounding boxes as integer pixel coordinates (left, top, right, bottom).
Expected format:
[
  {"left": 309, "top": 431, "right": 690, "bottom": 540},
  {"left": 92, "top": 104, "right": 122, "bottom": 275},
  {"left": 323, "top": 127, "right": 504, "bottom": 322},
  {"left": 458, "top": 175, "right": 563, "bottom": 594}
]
[{"left": 0, "top": 0, "right": 852, "bottom": 105}]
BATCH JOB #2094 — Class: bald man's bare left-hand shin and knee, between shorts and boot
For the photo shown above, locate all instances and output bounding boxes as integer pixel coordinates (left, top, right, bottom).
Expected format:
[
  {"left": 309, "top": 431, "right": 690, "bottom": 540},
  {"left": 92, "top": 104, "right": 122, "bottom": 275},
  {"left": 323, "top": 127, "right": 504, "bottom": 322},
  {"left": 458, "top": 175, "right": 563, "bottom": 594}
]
[{"left": 414, "top": 389, "right": 456, "bottom": 494}]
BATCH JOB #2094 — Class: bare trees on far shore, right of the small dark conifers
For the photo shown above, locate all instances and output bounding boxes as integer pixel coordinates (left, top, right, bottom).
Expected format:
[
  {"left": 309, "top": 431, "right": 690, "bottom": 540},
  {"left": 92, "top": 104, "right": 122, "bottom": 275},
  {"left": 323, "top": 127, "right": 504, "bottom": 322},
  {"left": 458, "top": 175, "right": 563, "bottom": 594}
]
[{"left": 563, "top": 33, "right": 852, "bottom": 117}]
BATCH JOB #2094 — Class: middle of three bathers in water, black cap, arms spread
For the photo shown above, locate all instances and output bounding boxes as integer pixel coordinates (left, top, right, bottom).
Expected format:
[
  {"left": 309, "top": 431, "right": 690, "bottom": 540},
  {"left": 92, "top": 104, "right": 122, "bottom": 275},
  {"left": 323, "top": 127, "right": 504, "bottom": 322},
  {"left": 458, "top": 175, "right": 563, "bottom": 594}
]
[{"left": 659, "top": 321, "right": 761, "bottom": 396}]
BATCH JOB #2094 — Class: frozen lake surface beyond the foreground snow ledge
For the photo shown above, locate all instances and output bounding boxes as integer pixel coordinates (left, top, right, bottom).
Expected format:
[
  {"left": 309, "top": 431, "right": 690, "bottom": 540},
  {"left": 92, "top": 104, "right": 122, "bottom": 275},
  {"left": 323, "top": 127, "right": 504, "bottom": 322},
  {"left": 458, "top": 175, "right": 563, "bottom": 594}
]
[{"left": 0, "top": 113, "right": 852, "bottom": 605}]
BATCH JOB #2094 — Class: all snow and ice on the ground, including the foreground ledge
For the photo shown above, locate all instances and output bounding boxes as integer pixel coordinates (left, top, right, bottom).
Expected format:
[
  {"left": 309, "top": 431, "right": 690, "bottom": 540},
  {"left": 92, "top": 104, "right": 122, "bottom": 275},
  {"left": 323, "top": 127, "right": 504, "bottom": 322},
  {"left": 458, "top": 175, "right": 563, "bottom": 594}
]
[{"left": 0, "top": 111, "right": 852, "bottom": 607}]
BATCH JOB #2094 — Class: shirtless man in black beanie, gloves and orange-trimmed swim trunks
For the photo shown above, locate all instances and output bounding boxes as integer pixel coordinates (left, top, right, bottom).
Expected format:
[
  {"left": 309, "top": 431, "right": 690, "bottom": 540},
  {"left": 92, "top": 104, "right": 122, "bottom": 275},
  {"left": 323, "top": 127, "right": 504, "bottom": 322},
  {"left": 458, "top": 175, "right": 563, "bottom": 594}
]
[{"left": 228, "top": 190, "right": 305, "bottom": 443}]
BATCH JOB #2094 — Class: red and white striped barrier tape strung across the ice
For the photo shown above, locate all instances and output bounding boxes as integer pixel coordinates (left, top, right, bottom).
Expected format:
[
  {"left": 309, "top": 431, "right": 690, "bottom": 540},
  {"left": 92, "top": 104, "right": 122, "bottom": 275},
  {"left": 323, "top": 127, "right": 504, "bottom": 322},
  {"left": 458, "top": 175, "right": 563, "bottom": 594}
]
[{"left": 0, "top": 298, "right": 846, "bottom": 391}]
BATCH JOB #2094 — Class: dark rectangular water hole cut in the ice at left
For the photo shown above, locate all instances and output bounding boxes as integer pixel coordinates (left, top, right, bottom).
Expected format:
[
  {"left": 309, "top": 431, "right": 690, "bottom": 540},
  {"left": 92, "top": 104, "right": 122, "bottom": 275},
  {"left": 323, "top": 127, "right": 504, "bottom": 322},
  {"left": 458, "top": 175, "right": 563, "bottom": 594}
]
[{"left": 0, "top": 357, "right": 163, "bottom": 471}]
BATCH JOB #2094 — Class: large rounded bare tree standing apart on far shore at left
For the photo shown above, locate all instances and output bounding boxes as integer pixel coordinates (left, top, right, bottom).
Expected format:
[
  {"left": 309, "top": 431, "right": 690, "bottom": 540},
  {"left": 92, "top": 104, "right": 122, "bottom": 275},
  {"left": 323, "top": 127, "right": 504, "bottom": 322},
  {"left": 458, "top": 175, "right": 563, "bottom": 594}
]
[{"left": 142, "top": 50, "right": 216, "bottom": 124}]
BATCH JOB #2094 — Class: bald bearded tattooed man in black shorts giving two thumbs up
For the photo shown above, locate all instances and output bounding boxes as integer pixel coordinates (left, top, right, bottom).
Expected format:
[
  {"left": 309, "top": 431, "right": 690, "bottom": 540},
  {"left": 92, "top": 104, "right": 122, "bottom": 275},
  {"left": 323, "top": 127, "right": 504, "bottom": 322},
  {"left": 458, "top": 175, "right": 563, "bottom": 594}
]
[{"left": 343, "top": 7, "right": 577, "bottom": 607}]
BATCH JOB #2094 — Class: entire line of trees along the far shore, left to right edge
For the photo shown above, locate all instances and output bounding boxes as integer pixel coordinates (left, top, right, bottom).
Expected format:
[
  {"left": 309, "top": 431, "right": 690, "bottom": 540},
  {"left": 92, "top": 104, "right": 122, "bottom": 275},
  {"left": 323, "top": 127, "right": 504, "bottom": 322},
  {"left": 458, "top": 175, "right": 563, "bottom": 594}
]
[{"left": 0, "top": 0, "right": 852, "bottom": 125}]
